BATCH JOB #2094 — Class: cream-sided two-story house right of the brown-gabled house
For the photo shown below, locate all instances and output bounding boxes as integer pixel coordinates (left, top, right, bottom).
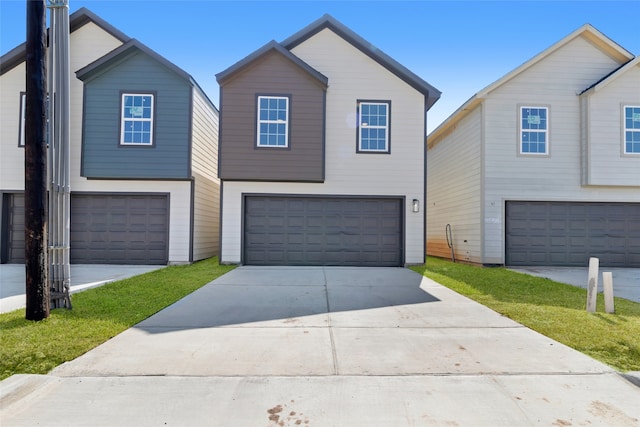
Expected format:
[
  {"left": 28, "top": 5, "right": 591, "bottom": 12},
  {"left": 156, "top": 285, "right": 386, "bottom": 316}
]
[{"left": 427, "top": 24, "right": 640, "bottom": 267}]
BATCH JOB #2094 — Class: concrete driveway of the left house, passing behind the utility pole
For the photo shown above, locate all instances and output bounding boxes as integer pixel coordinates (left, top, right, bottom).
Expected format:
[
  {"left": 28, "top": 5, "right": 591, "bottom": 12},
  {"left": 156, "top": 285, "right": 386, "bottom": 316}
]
[{"left": 0, "top": 264, "right": 165, "bottom": 313}]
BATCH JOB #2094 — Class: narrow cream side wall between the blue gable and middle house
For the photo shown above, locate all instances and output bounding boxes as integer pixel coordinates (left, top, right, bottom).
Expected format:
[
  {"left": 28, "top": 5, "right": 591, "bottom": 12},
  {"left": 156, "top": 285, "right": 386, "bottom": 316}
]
[{"left": 191, "top": 87, "right": 220, "bottom": 261}]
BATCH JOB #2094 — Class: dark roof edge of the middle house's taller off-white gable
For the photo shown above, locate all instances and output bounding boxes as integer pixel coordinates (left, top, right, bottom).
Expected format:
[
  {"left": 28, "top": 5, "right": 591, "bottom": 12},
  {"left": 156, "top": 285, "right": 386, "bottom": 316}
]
[{"left": 281, "top": 14, "right": 442, "bottom": 110}]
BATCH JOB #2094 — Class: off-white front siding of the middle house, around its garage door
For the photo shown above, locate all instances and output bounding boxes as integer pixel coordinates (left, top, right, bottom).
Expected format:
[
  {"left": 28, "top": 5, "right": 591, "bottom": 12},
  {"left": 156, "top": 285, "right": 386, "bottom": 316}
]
[{"left": 221, "top": 29, "right": 426, "bottom": 264}]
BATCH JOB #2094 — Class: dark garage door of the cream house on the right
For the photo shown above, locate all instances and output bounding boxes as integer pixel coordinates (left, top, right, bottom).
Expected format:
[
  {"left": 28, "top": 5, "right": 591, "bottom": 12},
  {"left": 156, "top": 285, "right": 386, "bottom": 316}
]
[{"left": 505, "top": 202, "right": 640, "bottom": 267}]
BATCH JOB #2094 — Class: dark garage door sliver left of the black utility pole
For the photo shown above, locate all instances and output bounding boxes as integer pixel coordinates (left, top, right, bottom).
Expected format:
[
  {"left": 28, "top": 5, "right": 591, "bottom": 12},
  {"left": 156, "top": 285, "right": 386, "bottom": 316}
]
[{"left": 2, "top": 193, "right": 24, "bottom": 264}]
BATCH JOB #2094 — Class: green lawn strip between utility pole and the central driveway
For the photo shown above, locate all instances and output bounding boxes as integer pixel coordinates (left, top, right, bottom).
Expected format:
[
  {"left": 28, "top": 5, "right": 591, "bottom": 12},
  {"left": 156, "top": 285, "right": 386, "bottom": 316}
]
[{"left": 0, "top": 258, "right": 235, "bottom": 380}]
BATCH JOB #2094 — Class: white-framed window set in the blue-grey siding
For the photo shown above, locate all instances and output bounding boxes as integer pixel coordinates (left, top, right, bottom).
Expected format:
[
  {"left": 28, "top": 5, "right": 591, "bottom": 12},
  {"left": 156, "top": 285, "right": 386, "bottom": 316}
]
[{"left": 120, "top": 93, "right": 154, "bottom": 145}]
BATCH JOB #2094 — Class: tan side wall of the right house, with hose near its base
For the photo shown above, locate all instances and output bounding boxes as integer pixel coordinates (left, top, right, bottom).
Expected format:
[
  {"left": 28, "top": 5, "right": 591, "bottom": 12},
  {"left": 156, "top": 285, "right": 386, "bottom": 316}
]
[{"left": 426, "top": 105, "right": 482, "bottom": 263}]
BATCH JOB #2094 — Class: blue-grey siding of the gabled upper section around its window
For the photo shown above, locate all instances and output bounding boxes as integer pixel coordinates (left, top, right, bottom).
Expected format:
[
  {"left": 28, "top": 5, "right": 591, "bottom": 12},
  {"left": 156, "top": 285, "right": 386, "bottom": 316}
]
[{"left": 82, "top": 50, "right": 191, "bottom": 179}]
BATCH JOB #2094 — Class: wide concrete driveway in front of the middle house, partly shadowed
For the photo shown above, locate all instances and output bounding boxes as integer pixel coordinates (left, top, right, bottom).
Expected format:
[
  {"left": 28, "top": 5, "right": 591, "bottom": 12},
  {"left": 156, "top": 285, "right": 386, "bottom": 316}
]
[{"left": 0, "top": 267, "right": 640, "bottom": 427}]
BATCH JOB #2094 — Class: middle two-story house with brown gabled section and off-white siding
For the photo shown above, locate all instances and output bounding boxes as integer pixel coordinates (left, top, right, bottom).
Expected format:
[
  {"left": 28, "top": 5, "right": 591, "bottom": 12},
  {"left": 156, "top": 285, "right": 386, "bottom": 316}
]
[{"left": 218, "top": 15, "right": 440, "bottom": 265}]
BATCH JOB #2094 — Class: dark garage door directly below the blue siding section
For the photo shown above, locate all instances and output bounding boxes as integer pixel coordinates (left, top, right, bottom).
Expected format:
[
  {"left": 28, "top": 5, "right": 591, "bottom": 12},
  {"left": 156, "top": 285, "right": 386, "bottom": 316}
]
[{"left": 71, "top": 194, "right": 169, "bottom": 264}]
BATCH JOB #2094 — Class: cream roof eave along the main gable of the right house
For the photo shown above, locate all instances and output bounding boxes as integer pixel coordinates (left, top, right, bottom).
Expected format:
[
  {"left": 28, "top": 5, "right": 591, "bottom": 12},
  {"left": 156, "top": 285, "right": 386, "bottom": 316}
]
[{"left": 427, "top": 24, "right": 634, "bottom": 143}]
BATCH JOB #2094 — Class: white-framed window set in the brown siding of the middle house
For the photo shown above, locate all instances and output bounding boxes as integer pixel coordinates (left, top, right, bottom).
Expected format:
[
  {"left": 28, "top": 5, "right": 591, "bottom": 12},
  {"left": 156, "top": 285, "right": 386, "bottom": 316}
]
[{"left": 256, "top": 96, "right": 289, "bottom": 148}]
